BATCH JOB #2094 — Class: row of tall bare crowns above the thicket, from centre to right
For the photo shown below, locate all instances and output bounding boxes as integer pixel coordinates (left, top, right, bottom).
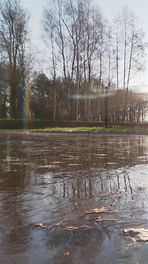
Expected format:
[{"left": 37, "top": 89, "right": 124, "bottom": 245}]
[{"left": 43, "top": 0, "right": 146, "bottom": 90}]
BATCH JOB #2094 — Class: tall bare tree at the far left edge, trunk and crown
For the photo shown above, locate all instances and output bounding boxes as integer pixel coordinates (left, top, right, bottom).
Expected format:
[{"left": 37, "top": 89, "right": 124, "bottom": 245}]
[{"left": 0, "top": 0, "right": 29, "bottom": 118}]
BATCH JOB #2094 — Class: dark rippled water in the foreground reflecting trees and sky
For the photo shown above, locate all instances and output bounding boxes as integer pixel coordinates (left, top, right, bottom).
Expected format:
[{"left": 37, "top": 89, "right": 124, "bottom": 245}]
[{"left": 0, "top": 134, "right": 148, "bottom": 264}]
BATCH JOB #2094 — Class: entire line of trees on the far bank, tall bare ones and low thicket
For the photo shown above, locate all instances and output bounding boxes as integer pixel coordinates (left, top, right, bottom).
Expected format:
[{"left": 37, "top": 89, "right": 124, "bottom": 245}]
[{"left": 0, "top": 0, "right": 147, "bottom": 123}]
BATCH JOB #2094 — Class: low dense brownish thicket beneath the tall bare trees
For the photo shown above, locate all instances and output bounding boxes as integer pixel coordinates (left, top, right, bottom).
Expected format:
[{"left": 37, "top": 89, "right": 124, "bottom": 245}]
[{"left": 30, "top": 74, "right": 147, "bottom": 123}]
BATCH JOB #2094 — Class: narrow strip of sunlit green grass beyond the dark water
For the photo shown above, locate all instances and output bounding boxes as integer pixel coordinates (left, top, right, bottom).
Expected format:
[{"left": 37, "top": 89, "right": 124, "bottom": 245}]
[{"left": 33, "top": 126, "right": 148, "bottom": 133}]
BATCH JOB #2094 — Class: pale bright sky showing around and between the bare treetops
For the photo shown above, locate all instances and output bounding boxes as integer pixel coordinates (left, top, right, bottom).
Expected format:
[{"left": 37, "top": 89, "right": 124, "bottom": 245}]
[{"left": 22, "top": 0, "right": 148, "bottom": 88}]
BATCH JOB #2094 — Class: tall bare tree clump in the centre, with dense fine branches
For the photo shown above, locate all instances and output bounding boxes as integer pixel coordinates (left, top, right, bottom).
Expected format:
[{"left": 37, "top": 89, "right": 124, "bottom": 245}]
[{"left": 43, "top": 0, "right": 105, "bottom": 119}]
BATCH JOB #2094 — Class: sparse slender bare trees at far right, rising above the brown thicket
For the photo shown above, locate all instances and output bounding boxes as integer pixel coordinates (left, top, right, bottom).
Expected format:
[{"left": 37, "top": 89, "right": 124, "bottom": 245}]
[{"left": 114, "top": 8, "right": 146, "bottom": 90}]
